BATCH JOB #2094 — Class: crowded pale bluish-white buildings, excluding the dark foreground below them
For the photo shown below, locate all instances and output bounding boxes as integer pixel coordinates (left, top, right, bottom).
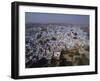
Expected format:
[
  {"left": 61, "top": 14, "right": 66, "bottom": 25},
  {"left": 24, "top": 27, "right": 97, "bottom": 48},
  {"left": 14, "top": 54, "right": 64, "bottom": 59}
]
[{"left": 25, "top": 24, "right": 89, "bottom": 67}]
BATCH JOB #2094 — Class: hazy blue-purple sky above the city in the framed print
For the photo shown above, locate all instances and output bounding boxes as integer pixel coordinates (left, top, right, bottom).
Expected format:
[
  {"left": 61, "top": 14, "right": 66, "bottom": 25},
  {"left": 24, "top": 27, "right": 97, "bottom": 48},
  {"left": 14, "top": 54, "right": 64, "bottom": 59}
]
[{"left": 25, "top": 12, "right": 89, "bottom": 25}]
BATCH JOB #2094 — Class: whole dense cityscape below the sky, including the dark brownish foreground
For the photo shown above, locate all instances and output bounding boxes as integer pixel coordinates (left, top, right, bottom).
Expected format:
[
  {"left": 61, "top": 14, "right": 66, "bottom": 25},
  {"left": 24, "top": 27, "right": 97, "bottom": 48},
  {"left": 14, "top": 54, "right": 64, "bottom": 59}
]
[{"left": 25, "top": 23, "right": 89, "bottom": 68}]
